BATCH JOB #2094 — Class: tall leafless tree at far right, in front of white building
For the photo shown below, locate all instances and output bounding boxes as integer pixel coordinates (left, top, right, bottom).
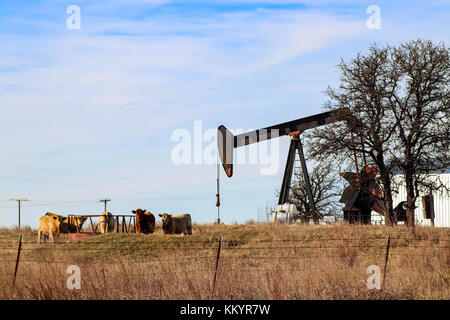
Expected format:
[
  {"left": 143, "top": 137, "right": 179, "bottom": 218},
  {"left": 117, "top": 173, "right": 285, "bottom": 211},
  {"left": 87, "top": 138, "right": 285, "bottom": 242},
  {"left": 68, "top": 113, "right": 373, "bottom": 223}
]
[{"left": 390, "top": 40, "right": 450, "bottom": 228}]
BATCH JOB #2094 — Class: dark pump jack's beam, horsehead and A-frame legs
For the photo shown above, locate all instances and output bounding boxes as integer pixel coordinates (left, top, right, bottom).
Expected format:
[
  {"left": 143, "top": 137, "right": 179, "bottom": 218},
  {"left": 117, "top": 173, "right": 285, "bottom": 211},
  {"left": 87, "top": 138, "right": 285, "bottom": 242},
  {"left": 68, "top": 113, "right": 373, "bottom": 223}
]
[{"left": 217, "top": 108, "right": 345, "bottom": 221}]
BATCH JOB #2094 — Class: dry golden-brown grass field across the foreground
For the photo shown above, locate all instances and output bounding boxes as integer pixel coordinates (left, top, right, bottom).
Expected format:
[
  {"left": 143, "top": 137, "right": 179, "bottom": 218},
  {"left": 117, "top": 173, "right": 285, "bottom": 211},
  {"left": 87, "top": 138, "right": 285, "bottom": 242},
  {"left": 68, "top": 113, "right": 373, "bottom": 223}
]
[{"left": 0, "top": 224, "right": 450, "bottom": 300}]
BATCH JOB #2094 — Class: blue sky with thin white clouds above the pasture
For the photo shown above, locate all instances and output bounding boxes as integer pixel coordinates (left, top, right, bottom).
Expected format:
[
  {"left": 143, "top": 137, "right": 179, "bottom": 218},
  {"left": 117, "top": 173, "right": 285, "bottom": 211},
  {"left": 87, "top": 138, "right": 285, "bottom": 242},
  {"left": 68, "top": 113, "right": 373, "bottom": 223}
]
[{"left": 0, "top": 0, "right": 450, "bottom": 227}]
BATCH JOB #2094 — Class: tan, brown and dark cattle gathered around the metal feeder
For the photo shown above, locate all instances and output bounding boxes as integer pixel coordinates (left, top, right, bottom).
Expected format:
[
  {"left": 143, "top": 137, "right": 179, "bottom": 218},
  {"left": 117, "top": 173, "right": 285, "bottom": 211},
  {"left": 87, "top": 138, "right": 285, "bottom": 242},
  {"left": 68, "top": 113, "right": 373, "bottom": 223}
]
[{"left": 38, "top": 209, "right": 192, "bottom": 243}]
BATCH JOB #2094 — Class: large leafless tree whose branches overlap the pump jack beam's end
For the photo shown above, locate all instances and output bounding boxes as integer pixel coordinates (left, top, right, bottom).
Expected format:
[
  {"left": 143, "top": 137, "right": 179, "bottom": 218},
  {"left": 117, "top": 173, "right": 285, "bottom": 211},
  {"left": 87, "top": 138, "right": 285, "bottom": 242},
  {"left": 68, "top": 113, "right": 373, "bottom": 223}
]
[{"left": 308, "top": 45, "right": 400, "bottom": 224}]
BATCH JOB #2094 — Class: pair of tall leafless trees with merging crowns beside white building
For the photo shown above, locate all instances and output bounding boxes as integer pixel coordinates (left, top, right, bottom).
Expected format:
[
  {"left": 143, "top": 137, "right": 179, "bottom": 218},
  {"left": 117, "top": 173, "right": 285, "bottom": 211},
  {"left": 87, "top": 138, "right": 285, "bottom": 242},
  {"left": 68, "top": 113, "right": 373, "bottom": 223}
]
[{"left": 308, "top": 40, "right": 450, "bottom": 229}]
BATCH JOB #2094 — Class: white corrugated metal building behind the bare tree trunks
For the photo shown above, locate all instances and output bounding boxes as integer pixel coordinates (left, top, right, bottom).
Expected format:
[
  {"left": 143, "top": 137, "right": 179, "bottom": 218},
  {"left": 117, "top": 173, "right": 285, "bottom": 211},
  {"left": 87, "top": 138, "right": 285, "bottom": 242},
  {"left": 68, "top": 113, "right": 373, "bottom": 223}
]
[{"left": 372, "top": 168, "right": 450, "bottom": 228}]
